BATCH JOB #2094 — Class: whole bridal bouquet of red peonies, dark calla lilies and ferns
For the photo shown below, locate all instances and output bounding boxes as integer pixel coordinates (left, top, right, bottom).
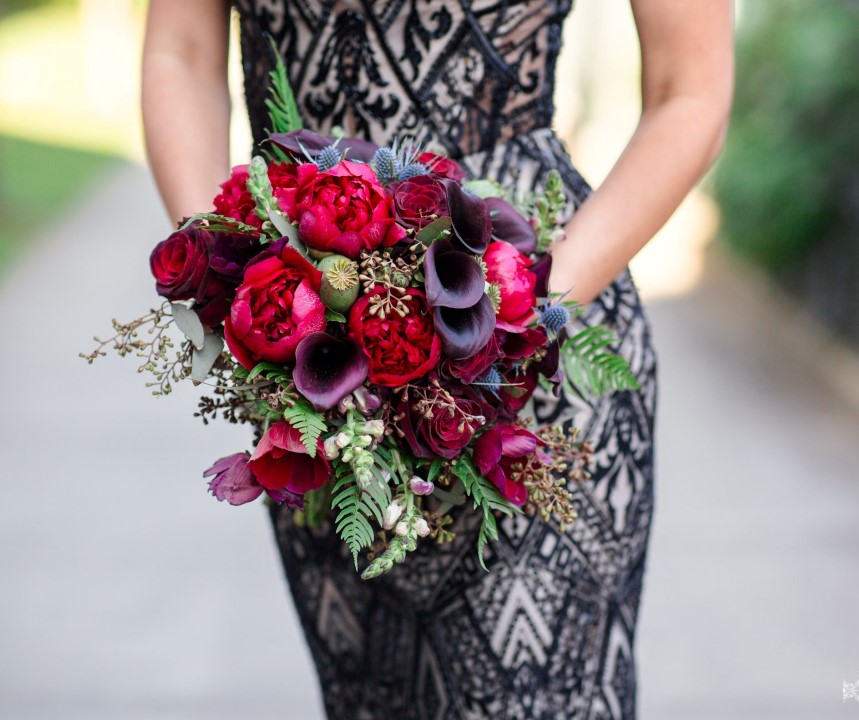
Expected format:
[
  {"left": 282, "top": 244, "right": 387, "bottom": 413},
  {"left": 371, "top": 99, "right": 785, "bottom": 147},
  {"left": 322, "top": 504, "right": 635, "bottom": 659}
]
[{"left": 84, "top": 56, "right": 635, "bottom": 578}]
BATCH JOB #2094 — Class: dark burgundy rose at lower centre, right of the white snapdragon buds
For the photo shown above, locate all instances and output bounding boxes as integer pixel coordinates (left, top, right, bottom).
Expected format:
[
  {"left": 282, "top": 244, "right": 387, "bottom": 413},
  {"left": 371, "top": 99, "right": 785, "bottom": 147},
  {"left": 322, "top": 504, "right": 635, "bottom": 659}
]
[{"left": 397, "top": 386, "right": 487, "bottom": 459}]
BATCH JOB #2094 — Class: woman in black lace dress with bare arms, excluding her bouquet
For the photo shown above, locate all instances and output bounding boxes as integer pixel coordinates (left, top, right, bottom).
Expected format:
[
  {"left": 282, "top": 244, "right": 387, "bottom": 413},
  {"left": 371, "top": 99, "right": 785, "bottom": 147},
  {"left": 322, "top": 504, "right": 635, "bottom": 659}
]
[{"left": 143, "top": 0, "right": 733, "bottom": 720}]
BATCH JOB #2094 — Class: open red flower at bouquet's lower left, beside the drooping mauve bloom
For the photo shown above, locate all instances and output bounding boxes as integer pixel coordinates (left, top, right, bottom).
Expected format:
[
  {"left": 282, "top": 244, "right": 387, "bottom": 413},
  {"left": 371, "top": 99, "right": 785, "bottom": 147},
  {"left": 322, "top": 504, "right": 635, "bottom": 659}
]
[{"left": 248, "top": 420, "right": 331, "bottom": 495}]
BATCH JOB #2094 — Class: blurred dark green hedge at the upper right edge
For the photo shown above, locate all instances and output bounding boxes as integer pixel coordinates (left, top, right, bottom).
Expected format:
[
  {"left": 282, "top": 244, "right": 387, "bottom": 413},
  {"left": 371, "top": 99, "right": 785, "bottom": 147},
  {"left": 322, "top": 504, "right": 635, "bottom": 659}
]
[{"left": 713, "top": 0, "right": 859, "bottom": 340}]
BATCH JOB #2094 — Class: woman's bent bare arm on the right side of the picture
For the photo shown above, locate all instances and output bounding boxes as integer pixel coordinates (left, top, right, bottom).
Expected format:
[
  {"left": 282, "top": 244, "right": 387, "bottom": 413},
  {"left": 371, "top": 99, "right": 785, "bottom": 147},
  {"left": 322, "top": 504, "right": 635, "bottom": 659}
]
[{"left": 549, "top": 0, "right": 734, "bottom": 303}]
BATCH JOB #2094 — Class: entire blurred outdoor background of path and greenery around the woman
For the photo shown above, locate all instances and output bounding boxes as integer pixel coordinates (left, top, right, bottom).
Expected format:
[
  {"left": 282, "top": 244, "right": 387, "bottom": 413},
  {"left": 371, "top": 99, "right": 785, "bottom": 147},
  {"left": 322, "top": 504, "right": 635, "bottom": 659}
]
[{"left": 0, "top": 0, "right": 859, "bottom": 720}]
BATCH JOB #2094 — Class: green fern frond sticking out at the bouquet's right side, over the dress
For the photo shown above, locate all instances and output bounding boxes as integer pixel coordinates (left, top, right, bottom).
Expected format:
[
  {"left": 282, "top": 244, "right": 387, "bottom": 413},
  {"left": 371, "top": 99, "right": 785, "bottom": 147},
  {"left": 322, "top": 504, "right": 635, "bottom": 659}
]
[{"left": 561, "top": 325, "right": 639, "bottom": 395}]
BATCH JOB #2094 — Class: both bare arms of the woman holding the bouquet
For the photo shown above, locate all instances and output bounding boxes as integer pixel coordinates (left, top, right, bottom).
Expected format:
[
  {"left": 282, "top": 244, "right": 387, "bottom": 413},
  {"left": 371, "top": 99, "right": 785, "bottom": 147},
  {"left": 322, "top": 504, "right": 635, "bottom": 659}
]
[{"left": 143, "top": 0, "right": 734, "bottom": 303}]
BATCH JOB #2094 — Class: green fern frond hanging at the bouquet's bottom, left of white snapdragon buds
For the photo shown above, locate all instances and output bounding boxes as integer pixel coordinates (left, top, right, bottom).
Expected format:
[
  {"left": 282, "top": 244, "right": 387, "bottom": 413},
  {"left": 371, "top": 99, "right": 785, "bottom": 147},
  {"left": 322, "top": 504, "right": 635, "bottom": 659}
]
[{"left": 331, "top": 463, "right": 390, "bottom": 570}]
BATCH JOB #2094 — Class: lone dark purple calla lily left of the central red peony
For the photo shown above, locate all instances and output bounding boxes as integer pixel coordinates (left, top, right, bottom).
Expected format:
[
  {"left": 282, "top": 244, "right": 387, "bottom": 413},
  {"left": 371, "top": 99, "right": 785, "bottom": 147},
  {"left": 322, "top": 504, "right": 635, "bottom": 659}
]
[{"left": 292, "top": 332, "right": 370, "bottom": 411}]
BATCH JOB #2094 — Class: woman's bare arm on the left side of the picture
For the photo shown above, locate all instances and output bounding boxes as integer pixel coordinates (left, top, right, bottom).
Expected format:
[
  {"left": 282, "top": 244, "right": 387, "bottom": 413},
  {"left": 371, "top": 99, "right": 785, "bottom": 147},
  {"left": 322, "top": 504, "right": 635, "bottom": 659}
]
[{"left": 142, "top": 0, "right": 230, "bottom": 221}]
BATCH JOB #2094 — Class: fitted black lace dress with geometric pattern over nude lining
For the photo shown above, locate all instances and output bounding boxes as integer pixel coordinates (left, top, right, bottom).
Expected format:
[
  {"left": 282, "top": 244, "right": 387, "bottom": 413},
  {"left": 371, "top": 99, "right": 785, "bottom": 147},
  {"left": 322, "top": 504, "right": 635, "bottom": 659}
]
[{"left": 236, "top": 0, "right": 656, "bottom": 720}]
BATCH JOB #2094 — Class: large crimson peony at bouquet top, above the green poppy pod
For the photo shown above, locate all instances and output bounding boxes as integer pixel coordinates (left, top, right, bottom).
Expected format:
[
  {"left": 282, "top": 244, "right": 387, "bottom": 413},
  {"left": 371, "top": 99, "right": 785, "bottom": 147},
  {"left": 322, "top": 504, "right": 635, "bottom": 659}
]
[{"left": 275, "top": 160, "right": 405, "bottom": 258}]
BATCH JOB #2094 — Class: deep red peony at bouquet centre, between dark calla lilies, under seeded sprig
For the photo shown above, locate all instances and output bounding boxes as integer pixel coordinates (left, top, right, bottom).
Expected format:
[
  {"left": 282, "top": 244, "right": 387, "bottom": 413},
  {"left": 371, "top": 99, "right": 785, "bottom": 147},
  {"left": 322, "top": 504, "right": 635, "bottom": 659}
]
[{"left": 349, "top": 286, "right": 441, "bottom": 387}]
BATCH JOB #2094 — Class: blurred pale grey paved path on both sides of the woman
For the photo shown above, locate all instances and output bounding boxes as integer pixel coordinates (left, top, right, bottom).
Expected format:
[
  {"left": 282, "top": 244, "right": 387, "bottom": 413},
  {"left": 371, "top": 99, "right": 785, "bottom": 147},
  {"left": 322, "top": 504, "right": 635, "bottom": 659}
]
[{"left": 0, "top": 167, "right": 859, "bottom": 720}]
